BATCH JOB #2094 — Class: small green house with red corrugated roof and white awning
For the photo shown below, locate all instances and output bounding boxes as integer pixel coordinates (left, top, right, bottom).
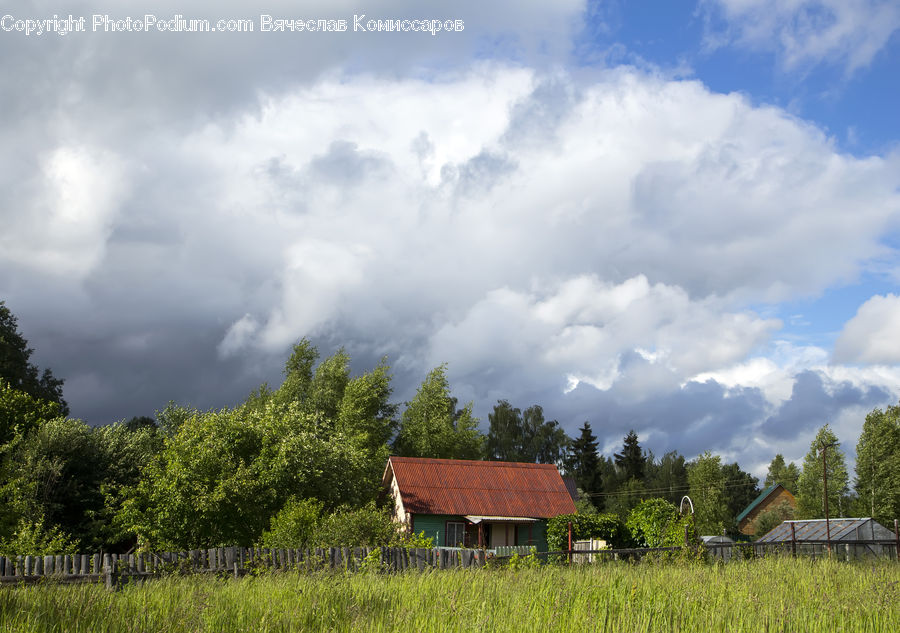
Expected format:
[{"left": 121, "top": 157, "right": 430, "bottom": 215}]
[{"left": 382, "top": 457, "right": 575, "bottom": 551}]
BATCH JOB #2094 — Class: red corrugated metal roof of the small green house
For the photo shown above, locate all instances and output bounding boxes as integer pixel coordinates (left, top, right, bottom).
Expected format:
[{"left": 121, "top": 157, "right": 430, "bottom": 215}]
[{"left": 384, "top": 457, "right": 575, "bottom": 518}]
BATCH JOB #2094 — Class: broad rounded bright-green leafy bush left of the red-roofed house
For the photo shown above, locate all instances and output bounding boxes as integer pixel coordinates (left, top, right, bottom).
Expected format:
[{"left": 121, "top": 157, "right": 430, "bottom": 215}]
[{"left": 122, "top": 402, "right": 373, "bottom": 549}]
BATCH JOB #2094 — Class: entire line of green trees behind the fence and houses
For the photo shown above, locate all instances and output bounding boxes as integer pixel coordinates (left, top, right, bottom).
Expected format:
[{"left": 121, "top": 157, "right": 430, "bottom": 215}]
[{"left": 0, "top": 302, "right": 900, "bottom": 553}]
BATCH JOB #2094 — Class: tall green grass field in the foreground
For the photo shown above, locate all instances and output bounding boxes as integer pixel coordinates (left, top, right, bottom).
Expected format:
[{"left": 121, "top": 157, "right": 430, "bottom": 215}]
[{"left": 0, "top": 558, "right": 900, "bottom": 633}]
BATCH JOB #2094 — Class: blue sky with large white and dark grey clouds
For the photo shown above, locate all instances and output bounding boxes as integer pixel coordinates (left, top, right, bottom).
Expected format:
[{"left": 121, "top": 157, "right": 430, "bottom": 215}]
[{"left": 0, "top": 0, "right": 900, "bottom": 476}]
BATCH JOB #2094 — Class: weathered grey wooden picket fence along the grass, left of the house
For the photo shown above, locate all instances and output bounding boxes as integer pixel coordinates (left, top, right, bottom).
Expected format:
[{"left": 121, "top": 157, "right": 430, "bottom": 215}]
[{"left": 0, "top": 547, "right": 492, "bottom": 588}]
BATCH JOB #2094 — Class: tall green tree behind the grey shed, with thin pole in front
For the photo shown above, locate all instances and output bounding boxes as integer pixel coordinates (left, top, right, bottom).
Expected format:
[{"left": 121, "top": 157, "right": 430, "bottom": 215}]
[{"left": 797, "top": 424, "right": 849, "bottom": 519}]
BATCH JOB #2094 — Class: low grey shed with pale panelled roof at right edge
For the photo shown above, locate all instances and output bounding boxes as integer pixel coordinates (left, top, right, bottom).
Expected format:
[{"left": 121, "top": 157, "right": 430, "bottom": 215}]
[{"left": 754, "top": 517, "right": 897, "bottom": 558}]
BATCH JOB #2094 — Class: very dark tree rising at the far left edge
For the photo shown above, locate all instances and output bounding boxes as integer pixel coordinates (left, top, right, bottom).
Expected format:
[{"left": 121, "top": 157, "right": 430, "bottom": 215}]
[{"left": 0, "top": 301, "right": 69, "bottom": 416}]
